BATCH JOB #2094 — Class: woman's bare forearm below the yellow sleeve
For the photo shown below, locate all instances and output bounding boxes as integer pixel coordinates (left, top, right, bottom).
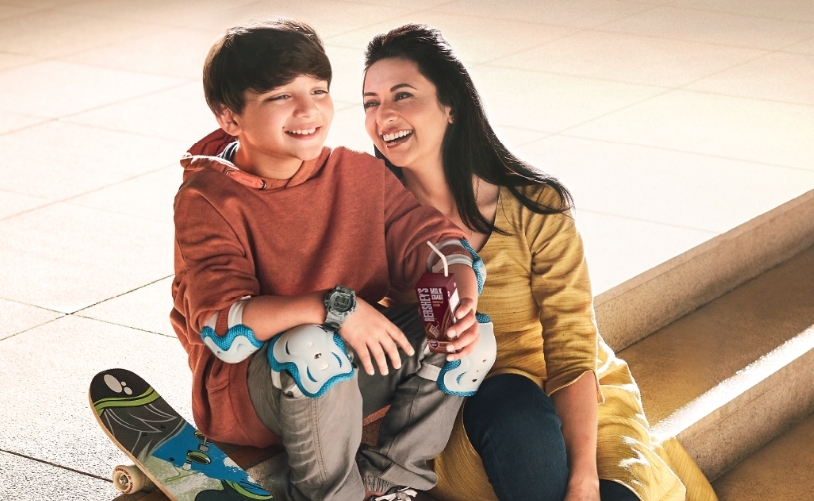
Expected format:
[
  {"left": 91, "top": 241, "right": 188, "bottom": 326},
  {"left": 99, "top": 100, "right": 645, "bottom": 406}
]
[{"left": 551, "top": 372, "right": 599, "bottom": 501}]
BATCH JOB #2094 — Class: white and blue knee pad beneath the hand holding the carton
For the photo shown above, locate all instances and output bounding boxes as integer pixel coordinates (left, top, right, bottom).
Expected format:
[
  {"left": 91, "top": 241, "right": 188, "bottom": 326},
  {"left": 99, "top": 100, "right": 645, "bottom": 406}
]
[{"left": 438, "top": 313, "right": 497, "bottom": 397}]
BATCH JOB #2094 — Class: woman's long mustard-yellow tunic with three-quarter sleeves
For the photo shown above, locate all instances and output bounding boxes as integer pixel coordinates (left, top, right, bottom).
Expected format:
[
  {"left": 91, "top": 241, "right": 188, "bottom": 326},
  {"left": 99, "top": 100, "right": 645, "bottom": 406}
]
[{"left": 432, "top": 185, "right": 717, "bottom": 501}]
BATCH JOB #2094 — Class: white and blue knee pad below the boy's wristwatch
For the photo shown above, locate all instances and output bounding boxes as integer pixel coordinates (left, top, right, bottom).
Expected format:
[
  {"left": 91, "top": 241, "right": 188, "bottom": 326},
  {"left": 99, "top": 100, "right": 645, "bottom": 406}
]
[{"left": 268, "top": 325, "right": 354, "bottom": 398}]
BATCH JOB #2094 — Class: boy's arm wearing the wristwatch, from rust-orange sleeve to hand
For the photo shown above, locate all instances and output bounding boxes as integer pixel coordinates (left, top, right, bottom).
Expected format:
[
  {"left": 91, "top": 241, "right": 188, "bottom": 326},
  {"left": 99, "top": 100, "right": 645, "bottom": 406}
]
[{"left": 175, "top": 187, "right": 412, "bottom": 368}]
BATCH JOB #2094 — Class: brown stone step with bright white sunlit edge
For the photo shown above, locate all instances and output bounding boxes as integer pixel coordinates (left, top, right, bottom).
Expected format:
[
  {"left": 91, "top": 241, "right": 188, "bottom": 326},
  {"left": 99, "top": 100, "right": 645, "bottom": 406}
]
[{"left": 619, "top": 242, "right": 814, "bottom": 480}]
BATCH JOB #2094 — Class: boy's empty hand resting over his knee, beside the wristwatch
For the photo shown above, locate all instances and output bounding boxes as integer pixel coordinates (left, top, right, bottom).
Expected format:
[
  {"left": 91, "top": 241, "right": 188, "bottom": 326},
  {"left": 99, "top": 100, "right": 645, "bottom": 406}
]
[{"left": 339, "top": 298, "right": 414, "bottom": 376}]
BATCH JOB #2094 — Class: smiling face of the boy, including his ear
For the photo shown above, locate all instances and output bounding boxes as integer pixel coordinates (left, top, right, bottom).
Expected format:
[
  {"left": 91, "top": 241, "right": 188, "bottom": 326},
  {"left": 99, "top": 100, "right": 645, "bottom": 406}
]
[{"left": 218, "top": 75, "right": 334, "bottom": 179}]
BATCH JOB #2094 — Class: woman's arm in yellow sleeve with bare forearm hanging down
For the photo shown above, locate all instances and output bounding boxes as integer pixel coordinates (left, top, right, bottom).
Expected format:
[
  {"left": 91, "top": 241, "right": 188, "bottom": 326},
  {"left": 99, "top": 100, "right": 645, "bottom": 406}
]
[{"left": 526, "top": 185, "right": 600, "bottom": 501}]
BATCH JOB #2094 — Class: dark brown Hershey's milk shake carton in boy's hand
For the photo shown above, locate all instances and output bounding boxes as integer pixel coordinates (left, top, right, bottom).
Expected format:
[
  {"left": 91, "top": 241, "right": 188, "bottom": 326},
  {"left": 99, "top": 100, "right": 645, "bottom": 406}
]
[{"left": 415, "top": 273, "right": 460, "bottom": 353}]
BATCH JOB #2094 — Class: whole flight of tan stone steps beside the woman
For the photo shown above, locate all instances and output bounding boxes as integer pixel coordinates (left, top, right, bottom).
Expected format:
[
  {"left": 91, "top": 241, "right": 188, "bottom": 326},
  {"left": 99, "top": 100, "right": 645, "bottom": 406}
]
[{"left": 116, "top": 191, "right": 814, "bottom": 501}]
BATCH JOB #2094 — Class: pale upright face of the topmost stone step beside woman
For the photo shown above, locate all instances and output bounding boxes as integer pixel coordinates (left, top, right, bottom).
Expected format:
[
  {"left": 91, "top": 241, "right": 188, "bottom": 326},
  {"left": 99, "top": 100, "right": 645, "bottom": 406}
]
[{"left": 594, "top": 190, "right": 814, "bottom": 352}]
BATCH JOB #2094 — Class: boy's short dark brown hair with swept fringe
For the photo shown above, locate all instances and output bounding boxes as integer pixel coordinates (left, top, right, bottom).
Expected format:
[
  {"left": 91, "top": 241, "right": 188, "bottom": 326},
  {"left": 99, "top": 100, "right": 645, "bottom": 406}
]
[{"left": 203, "top": 19, "right": 331, "bottom": 114}]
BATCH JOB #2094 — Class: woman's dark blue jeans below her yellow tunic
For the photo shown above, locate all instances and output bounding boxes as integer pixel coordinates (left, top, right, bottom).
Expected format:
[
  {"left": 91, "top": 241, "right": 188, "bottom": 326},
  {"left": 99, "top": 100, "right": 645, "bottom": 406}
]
[{"left": 463, "top": 374, "right": 638, "bottom": 501}]
